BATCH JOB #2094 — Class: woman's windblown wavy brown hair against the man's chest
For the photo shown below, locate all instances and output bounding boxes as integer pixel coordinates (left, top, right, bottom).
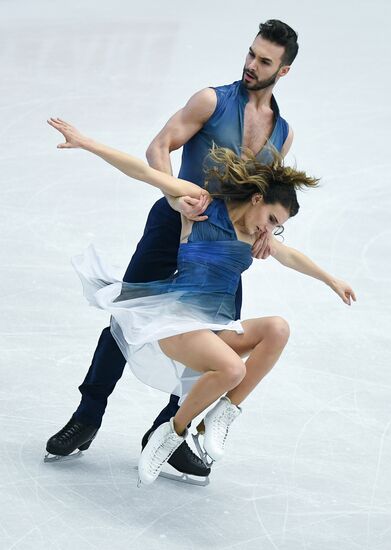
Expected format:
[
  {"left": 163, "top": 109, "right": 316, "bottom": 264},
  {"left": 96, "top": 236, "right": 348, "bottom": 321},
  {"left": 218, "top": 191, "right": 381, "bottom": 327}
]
[{"left": 205, "top": 144, "right": 319, "bottom": 217}]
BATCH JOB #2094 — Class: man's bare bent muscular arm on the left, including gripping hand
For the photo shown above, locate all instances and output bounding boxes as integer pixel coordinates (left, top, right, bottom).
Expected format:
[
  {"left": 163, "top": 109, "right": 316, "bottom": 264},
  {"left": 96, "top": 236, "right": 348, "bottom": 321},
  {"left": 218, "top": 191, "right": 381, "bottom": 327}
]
[{"left": 146, "top": 88, "right": 217, "bottom": 221}]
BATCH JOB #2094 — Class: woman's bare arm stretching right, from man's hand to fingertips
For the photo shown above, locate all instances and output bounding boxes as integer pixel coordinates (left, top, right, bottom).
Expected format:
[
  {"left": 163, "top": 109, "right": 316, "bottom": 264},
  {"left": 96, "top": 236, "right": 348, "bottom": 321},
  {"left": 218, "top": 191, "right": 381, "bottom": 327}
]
[{"left": 272, "top": 239, "right": 356, "bottom": 306}]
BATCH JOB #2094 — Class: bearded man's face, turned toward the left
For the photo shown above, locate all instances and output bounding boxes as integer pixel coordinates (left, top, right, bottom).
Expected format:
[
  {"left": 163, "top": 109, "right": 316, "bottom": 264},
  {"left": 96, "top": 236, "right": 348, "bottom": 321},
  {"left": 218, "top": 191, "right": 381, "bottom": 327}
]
[{"left": 242, "top": 36, "right": 289, "bottom": 91}]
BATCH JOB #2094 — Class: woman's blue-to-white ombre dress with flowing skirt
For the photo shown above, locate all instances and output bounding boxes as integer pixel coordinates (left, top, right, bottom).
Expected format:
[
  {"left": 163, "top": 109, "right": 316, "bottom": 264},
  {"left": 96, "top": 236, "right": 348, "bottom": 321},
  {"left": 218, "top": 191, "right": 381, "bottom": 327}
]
[{"left": 73, "top": 199, "right": 252, "bottom": 399}]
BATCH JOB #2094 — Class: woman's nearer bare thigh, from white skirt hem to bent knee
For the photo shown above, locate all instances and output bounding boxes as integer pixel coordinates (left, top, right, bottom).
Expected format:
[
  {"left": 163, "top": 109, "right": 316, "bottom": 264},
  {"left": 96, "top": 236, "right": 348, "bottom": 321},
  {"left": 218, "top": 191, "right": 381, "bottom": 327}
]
[{"left": 159, "top": 330, "right": 242, "bottom": 378}]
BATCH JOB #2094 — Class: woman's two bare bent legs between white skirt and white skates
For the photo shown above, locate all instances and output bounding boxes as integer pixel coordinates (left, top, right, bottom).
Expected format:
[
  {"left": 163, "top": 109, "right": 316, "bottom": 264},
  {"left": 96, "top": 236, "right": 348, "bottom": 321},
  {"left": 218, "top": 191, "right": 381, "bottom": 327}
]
[{"left": 159, "top": 317, "right": 289, "bottom": 440}]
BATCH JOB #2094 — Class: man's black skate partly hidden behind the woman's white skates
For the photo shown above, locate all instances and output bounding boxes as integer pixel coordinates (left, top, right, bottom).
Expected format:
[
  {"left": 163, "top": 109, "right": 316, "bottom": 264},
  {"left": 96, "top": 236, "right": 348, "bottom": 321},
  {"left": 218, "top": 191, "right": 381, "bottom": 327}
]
[{"left": 141, "top": 428, "right": 210, "bottom": 487}]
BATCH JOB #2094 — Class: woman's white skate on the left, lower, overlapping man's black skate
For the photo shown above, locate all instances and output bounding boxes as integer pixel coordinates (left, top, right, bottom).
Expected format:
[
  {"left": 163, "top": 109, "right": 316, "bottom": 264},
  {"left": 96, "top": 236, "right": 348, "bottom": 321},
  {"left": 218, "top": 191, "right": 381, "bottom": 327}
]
[{"left": 137, "top": 418, "right": 187, "bottom": 487}]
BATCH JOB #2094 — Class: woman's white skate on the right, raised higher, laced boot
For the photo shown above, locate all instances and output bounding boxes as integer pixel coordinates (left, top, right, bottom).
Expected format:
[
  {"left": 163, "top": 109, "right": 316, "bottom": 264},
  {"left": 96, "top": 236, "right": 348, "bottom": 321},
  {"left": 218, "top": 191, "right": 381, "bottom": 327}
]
[{"left": 193, "top": 397, "right": 242, "bottom": 465}]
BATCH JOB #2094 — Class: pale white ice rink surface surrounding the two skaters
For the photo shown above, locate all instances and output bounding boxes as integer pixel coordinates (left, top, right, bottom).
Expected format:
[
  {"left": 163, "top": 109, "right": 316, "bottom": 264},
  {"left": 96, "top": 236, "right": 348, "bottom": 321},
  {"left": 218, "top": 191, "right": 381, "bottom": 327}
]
[{"left": 0, "top": 0, "right": 391, "bottom": 550}]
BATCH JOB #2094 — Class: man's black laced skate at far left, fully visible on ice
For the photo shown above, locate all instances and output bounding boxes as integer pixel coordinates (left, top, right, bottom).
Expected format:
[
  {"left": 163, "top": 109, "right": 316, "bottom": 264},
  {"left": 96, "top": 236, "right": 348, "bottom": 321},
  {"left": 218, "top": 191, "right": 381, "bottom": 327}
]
[{"left": 44, "top": 416, "right": 99, "bottom": 462}]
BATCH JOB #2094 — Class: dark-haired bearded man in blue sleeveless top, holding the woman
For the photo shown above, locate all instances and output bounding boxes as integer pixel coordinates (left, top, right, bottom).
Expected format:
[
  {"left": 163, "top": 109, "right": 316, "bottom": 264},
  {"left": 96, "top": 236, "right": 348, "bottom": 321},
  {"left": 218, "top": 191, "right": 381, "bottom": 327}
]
[{"left": 46, "top": 20, "right": 298, "bottom": 486}]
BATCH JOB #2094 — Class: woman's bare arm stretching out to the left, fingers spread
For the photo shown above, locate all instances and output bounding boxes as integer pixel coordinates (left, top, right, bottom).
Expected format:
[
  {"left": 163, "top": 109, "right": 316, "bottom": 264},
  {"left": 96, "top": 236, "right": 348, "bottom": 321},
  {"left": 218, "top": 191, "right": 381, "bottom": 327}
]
[{"left": 48, "top": 118, "right": 207, "bottom": 199}]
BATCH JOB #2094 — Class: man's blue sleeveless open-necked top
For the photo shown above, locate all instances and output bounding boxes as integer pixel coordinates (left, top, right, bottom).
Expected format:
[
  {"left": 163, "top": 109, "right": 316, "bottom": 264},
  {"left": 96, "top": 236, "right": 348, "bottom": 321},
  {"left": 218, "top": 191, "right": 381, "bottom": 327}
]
[{"left": 178, "top": 80, "right": 289, "bottom": 186}]
